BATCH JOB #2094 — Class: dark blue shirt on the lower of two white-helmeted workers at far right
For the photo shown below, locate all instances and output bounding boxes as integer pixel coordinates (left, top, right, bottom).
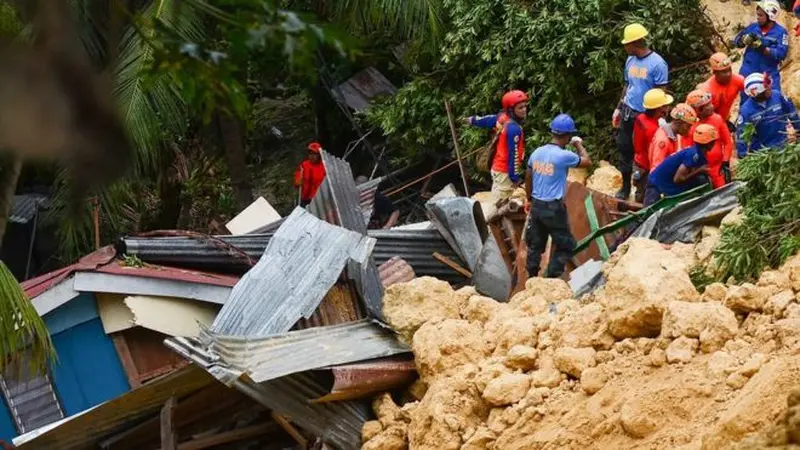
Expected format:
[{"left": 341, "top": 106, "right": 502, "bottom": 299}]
[{"left": 736, "top": 90, "right": 800, "bottom": 158}]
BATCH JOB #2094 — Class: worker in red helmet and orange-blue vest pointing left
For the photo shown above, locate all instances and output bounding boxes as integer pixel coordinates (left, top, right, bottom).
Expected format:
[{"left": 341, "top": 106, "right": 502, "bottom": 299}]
[{"left": 467, "top": 91, "right": 528, "bottom": 201}]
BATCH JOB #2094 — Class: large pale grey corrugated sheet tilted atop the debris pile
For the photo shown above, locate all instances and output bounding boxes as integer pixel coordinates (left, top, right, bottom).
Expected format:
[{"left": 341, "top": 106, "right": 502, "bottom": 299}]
[{"left": 211, "top": 208, "right": 375, "bottom": 336}]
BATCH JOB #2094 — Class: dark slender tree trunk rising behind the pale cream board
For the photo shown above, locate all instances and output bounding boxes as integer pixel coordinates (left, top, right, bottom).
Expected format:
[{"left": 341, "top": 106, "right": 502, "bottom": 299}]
[{"left": 219, "top": 112, "right": 253, "bottom": 211}]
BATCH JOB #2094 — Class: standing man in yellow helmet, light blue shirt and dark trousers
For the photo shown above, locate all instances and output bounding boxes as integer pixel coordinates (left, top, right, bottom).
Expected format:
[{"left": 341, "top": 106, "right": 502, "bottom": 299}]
[{"left": 611, "top": 23, "right": 669, "bottom": 199}]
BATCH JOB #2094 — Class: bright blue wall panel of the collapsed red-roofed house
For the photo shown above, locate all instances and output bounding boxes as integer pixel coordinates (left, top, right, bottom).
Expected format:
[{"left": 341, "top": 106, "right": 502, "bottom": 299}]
[{"left": 52, "top": 318, "right": 130, "bottom": 416}]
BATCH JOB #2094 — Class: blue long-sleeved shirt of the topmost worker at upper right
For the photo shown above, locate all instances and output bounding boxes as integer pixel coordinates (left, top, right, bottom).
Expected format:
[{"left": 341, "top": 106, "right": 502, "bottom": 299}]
[{"left": 733, "top": 22, "right": 789, "bottom": 90}]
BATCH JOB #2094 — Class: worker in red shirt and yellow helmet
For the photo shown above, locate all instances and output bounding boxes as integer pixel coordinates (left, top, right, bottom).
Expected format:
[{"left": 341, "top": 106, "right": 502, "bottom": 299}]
[{"left": 633, "top": 88, "right": 674, "bottom": 203}]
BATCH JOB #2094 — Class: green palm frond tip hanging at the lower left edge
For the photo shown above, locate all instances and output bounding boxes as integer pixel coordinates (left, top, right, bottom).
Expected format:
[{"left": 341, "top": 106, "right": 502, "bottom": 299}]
[{"left": 0, "top": 261, "right": 55, "bottom": 372}]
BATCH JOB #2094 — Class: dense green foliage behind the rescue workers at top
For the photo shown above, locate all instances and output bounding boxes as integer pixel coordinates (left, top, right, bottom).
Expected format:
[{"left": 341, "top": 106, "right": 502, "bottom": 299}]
[{"left": 369, "top": 0, "right": 714, "bottom": 167}]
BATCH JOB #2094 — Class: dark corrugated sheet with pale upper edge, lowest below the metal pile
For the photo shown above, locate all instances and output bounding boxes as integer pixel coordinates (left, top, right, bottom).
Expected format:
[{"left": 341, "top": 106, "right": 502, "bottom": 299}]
[{"left": 170, "top": 339, "right": 370, "bottom": 450}]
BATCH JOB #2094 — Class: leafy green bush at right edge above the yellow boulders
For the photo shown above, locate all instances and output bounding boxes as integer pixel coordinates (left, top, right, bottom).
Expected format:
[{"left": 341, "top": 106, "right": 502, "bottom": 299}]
[{"left": 714, "top": 144, "right": 800, "bottom": 282}]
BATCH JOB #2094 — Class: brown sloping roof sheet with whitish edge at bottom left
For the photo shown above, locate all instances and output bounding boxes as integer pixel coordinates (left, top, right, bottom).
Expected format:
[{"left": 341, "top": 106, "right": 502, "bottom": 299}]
[{"left": 14, "top": 366, "right": 215, "bottom": 450}]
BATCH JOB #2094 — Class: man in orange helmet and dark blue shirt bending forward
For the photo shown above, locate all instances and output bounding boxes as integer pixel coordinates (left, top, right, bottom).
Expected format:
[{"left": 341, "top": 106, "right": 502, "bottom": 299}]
[{"left": 644, "top": 124, "right": 719, "bottom": 206}]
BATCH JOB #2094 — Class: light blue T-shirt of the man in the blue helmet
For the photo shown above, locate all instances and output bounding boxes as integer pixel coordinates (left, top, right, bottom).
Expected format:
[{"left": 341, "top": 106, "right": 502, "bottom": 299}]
[{"left": 528, "top": 144, "right": 581, "bottom": 202}]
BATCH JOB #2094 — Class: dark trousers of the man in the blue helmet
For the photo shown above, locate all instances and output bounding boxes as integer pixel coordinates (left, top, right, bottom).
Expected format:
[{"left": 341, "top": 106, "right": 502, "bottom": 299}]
[{"left": 525, "top": 200, "right": 575, "bottom": 278}]
